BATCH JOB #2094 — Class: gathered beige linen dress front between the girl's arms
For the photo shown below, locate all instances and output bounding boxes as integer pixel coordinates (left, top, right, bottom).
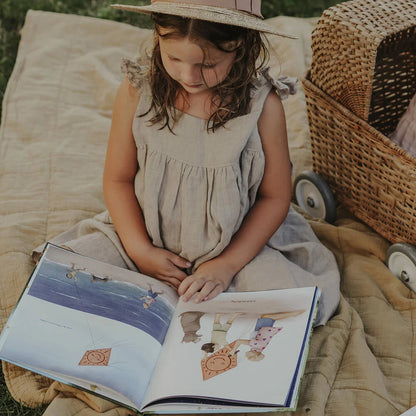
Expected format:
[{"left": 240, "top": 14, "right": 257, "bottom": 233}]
[{"left": 130, "top": 65, "right": 271, "bottom": 270}]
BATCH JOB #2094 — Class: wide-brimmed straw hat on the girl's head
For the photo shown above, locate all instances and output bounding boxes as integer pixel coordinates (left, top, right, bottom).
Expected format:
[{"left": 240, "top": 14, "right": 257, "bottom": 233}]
[{"left": 111, "top": 0, "right": 296, "bottom": 39}]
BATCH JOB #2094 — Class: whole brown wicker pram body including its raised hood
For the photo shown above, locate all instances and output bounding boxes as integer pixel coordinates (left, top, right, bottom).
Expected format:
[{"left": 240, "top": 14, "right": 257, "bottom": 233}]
[{"left": 303, "top": 0, "right": 416, "bottom": 244}]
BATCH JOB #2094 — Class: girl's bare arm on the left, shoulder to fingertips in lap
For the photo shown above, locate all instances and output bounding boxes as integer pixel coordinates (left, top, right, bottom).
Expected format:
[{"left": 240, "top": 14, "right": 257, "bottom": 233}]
[{"left": 103, "top": 78, "right": 189, "bottom": 287}]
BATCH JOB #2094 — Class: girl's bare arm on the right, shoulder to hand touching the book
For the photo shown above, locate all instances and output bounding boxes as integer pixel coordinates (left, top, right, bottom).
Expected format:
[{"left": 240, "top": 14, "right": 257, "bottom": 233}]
[{"left": 179, "top": 92, "right": 291, "bottom": 302}]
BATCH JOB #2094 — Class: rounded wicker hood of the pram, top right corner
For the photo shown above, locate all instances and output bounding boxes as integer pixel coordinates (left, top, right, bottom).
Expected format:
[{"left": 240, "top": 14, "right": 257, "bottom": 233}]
[{"left": 310, "top": 0, "right": 416, "bottom": 134}]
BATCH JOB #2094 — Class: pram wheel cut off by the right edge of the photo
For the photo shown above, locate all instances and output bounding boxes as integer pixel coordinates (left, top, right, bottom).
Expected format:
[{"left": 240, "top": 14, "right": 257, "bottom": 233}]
[{"left": 386, "top": 243, "right": 416, "bottom": 292}]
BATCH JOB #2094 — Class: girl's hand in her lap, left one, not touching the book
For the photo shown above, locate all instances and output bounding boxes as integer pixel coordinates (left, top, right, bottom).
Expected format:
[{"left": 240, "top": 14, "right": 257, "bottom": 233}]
[{"left": 132, "top": 246, "right": 191, "bottom": 289}]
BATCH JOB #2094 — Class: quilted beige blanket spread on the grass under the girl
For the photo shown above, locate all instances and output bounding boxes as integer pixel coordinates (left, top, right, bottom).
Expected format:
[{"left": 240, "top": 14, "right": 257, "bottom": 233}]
[{"left": 0, "top": 11, "right": 416, "bottom": 416}]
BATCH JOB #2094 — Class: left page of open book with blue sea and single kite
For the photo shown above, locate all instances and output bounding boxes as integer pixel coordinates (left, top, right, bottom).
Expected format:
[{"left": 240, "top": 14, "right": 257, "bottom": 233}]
[{"left": 0, "top": 245, "right": 177, "bottom": 407}]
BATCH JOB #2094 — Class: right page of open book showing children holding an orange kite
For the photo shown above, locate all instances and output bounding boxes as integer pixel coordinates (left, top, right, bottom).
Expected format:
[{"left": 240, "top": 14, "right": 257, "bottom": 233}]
[{"left": 146, "top": 288, "right": 316, "bottom": 406}]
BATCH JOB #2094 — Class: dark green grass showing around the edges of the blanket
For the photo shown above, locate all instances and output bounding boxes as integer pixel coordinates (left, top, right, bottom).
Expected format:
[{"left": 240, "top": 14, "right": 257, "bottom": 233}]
[{"left": 0, "top": 0, "right": 339, "bottom": 416}]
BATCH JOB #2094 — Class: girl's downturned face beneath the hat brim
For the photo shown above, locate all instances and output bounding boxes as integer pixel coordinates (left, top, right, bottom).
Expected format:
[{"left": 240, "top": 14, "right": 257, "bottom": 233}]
[{"left": 159, "top": 28, "right": 235, "bottom": 94}]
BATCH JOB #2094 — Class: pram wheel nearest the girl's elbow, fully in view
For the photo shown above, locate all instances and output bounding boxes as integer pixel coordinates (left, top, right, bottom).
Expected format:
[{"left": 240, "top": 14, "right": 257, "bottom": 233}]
[{"left": 293, "top": 171, "right": 337, "bottom": 223}]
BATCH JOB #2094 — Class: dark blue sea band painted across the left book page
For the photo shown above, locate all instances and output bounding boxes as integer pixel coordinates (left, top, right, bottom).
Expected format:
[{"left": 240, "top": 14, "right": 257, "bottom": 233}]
[{"left": 28, "top": 259, "right": 173, "bottom": 344}]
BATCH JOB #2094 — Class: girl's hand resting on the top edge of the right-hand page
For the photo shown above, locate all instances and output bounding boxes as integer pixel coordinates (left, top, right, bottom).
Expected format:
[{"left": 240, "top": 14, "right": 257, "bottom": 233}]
[{"left": 178, "top": 259, "right": 235, "bottom": 303}]
